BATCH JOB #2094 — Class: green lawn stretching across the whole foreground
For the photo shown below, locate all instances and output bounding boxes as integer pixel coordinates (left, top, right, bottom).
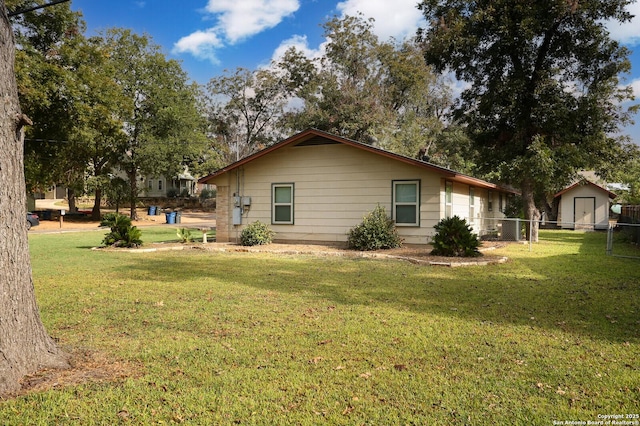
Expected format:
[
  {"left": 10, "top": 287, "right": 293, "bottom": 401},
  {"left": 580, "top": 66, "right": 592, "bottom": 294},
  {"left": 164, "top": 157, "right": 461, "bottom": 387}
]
[{"left": 0, "top": 229, "right": 640, "bottom": 425}]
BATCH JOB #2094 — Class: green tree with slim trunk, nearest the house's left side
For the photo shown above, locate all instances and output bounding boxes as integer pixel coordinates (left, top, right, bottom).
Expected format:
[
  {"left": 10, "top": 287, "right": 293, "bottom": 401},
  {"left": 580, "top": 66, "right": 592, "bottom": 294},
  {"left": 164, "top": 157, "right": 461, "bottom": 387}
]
[{"left": 103, "top": 29, "right": 204, "bottom": 219}]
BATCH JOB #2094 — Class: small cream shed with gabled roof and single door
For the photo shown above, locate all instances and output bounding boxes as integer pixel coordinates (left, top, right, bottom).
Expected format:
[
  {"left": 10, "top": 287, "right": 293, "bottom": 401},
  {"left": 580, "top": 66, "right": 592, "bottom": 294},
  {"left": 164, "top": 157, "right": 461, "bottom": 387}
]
[{"left": 554, "top": 179, "right": 616, "bottom": 229}]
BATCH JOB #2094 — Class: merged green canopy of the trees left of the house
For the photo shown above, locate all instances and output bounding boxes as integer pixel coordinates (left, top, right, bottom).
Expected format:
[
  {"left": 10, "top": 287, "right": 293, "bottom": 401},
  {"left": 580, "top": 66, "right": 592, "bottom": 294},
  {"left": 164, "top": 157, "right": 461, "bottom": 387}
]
[{"left": 10, "top": 5, "right": 206, "bottom": 219}]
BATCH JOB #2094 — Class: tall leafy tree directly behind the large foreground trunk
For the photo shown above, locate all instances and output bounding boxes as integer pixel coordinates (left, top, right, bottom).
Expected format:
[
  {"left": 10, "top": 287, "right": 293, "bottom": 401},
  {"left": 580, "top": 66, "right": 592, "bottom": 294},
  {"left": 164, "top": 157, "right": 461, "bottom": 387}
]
[{"left": 7, "top": 0, "right": 83, "bottom": 191}]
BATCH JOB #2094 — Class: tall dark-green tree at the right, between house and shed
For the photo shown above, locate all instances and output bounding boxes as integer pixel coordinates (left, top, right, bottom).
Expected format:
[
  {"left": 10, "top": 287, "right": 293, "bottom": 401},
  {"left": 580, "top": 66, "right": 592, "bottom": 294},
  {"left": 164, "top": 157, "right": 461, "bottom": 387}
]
[{"left": 419, "top": 0, "right": 632, "bottom": 240}]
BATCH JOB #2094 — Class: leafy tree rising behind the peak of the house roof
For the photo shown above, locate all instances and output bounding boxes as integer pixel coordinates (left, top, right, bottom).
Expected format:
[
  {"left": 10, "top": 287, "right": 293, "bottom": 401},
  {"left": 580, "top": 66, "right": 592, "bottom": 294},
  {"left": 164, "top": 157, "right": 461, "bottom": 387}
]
[{"left": 278, "top": 16, "right": 451, "bottom": 157}]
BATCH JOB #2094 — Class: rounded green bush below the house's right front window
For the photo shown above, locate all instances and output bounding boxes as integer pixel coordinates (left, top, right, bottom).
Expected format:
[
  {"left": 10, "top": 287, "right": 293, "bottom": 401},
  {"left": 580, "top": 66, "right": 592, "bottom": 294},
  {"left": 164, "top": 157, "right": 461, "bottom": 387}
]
[{"left": 347, "top": 205, "right": 402, "bottom": 251}]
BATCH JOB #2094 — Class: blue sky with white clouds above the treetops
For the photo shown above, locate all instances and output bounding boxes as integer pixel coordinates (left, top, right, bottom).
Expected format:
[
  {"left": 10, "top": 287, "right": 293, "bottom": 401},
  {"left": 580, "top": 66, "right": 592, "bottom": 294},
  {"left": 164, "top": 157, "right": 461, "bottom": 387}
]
[{"left": 71, "top": 0, "right": 640, "bottom": 145}]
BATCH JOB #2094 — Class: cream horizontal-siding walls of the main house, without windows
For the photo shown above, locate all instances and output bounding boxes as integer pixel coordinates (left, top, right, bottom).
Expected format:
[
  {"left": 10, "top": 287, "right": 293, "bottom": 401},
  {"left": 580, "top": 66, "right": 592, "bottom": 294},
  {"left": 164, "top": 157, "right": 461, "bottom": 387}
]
[{"left": 210, "top": 144, "right": 508, "bottom": 244}]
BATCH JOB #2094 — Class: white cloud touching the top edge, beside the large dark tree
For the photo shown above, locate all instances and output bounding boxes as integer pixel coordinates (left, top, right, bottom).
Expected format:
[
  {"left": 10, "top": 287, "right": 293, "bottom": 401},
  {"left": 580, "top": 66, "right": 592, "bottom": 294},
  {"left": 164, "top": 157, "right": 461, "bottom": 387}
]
[{"left": 336, "top": 0, "right": 425, "bottom": 41}]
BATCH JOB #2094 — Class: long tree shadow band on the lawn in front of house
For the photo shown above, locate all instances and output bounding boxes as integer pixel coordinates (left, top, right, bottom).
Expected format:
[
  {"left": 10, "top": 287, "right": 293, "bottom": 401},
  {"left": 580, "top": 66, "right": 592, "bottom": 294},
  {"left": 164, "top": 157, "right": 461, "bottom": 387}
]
[{"left": 116, "top": 233, "right": 640, "bottom": 342}]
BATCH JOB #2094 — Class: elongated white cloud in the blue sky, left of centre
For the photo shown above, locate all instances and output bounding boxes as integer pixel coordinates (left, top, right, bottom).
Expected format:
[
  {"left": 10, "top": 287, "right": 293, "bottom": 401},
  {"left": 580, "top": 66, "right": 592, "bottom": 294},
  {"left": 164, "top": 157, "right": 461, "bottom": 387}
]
[{"left": 173, "top": 0, "right": 300, "bottom": 63}]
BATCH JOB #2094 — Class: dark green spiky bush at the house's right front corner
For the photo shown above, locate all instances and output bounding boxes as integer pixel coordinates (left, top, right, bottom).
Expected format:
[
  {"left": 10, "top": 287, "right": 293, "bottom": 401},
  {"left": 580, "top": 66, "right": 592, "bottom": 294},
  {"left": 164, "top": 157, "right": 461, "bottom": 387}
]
[{"left": 431, "top": 216, "right": 482, "bottom": 257}]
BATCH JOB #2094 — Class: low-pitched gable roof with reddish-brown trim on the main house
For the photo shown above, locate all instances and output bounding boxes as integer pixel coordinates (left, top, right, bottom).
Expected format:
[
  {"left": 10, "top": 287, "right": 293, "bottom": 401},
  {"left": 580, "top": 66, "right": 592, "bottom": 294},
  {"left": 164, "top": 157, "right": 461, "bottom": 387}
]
[{"left": 198, "top": 129, "right": 517, "bottom": 194}]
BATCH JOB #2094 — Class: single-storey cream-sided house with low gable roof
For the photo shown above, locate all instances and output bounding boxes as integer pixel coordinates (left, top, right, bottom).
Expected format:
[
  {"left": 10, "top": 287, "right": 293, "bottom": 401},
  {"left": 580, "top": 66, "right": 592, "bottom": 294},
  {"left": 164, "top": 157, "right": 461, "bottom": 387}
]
[{"left": 199, "top": 129, "right": 514, "bottom": 244}]
